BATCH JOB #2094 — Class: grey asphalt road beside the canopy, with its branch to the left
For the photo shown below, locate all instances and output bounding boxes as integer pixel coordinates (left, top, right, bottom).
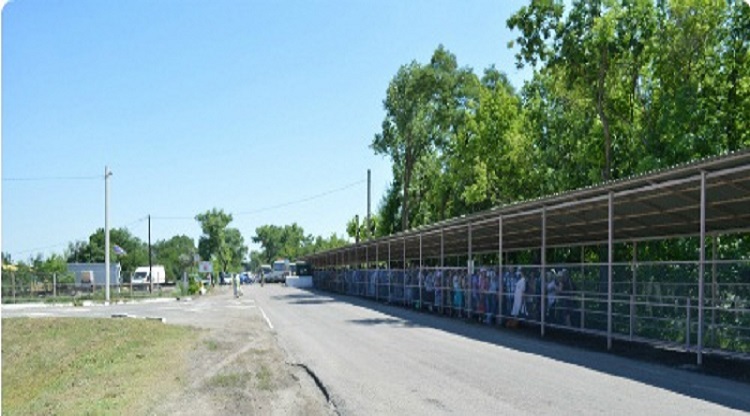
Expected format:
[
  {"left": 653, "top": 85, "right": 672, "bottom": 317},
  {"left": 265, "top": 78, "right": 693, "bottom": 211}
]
[{"left": 2, "top": 285, "right": 750, "bottom": 416}]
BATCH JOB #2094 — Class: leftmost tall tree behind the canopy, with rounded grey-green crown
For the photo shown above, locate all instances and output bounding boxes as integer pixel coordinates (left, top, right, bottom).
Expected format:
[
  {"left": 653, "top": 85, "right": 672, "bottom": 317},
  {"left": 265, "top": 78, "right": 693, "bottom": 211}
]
[{"left": 371, "top": 45, "right": 479, "bottom": 230}]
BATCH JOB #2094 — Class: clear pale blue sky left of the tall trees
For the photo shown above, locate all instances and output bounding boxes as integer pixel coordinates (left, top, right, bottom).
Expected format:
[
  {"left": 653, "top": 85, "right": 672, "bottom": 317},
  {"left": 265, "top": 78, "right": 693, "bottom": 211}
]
[{"left": 2, "top": 0, "right": 530, "bottom": 259}]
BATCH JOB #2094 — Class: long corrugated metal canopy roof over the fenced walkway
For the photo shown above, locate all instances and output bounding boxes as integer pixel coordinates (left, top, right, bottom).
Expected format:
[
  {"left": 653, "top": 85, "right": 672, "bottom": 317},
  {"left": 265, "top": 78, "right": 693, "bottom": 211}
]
[{"left": 307, "top": 149, "right": 750, "bottom": 265}]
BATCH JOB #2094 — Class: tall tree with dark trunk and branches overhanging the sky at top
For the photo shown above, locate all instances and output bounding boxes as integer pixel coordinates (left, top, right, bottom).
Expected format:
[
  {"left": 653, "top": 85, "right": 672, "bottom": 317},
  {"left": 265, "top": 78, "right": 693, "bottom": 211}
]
[{"left": 508, "top": 0, "right": 654, "bottom": 180}]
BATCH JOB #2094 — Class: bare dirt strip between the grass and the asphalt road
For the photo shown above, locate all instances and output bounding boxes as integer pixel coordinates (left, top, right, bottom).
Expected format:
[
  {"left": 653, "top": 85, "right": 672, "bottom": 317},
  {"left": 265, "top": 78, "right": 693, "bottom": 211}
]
[{"left": 149, "top": 288, "right": 336, "bottom": 415}]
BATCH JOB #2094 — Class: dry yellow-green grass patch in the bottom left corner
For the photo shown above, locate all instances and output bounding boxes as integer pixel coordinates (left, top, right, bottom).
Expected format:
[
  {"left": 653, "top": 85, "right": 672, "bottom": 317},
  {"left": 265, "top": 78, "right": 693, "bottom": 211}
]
[{"left": 2, "top": 318, "right": 198, "bottom": 415}]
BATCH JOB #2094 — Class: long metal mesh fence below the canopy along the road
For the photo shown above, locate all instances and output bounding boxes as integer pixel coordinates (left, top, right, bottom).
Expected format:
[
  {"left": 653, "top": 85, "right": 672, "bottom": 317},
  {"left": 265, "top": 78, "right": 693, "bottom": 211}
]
[{"left": 313, "top": 261, "right": 750, "bottom": 358}]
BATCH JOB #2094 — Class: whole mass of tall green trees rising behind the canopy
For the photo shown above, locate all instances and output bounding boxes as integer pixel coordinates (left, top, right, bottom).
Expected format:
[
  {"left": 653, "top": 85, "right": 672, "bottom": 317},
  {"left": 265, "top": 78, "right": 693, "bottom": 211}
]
[{"left": 374, "top": 0, "right": 750, "bottom": 231}]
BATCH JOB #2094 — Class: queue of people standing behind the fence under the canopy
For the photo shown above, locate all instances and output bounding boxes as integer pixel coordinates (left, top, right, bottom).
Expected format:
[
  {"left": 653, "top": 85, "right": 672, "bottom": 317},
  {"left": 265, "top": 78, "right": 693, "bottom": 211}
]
[{"left": 316, "top": 267, "right": 575, "bottom": 327}]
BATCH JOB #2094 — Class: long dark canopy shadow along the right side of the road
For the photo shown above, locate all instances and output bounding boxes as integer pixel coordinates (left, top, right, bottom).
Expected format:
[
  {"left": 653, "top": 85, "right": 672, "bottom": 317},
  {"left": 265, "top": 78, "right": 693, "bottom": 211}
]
[{"left": 275, "top": 289, "right": 750, "bottom": 412}]
